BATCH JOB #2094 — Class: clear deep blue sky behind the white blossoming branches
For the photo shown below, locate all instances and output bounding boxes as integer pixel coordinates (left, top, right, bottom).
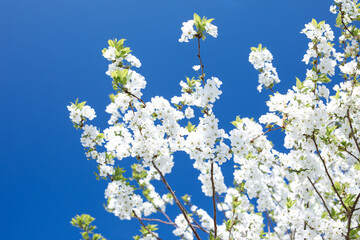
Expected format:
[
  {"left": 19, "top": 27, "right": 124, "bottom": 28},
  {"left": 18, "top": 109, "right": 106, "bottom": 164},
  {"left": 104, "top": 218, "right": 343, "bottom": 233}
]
[{"left": 0, "top": 0, "right": 335, "bottom": 240}]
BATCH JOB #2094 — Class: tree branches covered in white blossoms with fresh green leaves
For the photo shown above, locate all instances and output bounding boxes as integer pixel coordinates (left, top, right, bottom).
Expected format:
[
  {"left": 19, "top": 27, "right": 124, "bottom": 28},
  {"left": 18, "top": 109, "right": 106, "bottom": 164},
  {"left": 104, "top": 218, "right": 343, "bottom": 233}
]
[{"left": 68, "top": 0, "right": 360, "bottom": 240}]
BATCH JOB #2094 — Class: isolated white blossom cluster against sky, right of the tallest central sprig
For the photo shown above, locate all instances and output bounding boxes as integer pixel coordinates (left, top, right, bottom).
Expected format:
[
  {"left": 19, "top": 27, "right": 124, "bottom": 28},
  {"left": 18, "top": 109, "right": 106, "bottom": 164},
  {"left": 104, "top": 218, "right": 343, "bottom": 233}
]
[{"left": 249, "top": 45, "right": 280, "bottom": 92}]
